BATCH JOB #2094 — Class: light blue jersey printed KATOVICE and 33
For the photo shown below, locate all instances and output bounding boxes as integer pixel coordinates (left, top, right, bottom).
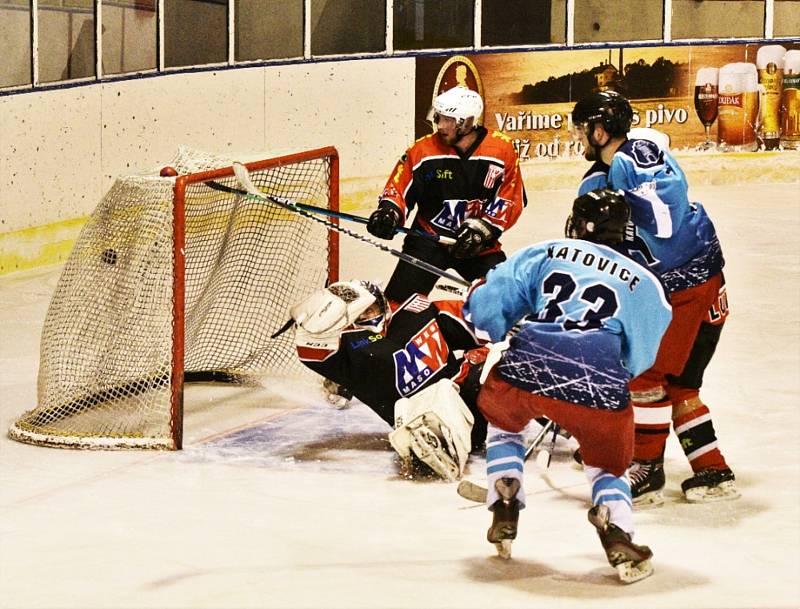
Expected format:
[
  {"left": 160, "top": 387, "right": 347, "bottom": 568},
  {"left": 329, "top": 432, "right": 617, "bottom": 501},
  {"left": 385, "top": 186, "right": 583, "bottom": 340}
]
[{"left": 464, "top": 239, "right": 672, "bottom": 410}]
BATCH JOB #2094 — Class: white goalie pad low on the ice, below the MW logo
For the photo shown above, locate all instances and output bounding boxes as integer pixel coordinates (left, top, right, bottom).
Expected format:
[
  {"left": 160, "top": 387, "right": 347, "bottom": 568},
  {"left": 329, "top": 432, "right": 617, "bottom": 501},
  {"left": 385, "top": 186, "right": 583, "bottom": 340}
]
[{"left": 389, "top": 379, "right": 475, "bottom": 481}]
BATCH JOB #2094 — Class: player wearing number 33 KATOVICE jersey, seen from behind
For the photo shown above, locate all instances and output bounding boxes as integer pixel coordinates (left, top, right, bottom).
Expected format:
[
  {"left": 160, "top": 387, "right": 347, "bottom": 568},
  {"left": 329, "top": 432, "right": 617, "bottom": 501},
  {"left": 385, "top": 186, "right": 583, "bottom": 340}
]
[{"left": 464, "top": 190, "right": 671, "bottom": 582}]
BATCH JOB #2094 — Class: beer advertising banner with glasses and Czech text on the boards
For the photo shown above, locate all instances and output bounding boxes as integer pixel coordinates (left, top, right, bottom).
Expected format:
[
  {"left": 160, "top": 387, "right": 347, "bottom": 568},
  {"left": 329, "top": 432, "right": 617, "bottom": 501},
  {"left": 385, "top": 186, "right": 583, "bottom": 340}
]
[{"left": 415, "top": 43, "right": 800, "bottom": 160}]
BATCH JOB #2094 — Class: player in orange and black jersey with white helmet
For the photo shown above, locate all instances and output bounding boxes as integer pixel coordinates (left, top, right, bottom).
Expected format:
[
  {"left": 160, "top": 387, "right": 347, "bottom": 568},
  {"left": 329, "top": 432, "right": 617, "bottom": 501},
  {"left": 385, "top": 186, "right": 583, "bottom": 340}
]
[{"left": 367, "top": 87, "right": 527, "bottom": 302}]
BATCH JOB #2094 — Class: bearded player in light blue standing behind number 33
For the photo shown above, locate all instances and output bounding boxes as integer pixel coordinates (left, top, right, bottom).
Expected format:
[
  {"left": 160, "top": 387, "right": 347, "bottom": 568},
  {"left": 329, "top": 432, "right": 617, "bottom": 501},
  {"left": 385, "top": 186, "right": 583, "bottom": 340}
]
[{"left": 572, "top": 91, "right": 739, "bottom": 506}]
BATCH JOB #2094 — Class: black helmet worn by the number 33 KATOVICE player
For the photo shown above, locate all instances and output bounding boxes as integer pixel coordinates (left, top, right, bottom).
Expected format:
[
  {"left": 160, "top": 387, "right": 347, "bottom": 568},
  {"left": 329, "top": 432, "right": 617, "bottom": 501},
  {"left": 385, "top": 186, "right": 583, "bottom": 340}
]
[{"left": 564, "top": 188, "right": 631, "bottom": 244}]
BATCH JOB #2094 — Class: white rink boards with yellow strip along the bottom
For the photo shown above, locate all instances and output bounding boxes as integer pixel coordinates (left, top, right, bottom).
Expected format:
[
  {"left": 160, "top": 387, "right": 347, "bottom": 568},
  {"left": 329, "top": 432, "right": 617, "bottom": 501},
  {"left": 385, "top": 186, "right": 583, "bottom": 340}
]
[{"left": 0, "top": 52, "right": 800, "bottom": 274}]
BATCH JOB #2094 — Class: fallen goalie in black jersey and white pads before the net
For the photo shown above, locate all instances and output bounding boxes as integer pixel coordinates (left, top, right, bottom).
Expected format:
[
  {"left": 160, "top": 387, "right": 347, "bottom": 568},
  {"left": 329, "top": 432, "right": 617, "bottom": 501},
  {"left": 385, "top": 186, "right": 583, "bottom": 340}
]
[{"left": 291, "top": 281, "right": 486, "bottom": 481}]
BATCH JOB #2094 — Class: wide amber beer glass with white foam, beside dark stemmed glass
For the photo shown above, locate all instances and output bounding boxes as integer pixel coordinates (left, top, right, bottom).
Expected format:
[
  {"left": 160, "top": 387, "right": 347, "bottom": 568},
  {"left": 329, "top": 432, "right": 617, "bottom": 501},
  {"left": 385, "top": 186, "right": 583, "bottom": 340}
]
[{"left": 717, "top": 62, "right": 759, "bottom": 150}]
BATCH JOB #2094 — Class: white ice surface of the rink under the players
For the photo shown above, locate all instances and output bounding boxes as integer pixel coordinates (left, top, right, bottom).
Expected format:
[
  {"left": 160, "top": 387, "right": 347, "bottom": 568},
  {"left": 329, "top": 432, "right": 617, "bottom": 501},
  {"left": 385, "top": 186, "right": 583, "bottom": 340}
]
[{"left": 0, "top": 176, "right": 800, "bottom": 609}]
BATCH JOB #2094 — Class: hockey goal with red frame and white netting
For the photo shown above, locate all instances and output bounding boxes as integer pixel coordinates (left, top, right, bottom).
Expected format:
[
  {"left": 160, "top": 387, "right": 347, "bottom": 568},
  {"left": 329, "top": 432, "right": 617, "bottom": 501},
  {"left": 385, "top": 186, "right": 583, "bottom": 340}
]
[{"left": 9, "top": 148, "right": 338, "bottom": 449}]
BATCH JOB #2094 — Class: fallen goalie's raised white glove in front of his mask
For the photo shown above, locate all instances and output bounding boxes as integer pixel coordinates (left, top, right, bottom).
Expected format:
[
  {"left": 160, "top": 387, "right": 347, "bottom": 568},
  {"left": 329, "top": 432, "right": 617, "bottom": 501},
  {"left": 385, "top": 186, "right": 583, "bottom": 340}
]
[{"left": 289, "top": 281, "right": 375, "bottom": 350}]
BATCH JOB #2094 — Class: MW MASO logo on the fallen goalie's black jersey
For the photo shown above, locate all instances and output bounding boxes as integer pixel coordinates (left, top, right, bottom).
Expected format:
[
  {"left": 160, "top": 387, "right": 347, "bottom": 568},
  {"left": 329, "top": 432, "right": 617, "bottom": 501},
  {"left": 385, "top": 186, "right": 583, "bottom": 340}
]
[{"left": 392, "top": 319, "right": 450, "bottom": 397}]
